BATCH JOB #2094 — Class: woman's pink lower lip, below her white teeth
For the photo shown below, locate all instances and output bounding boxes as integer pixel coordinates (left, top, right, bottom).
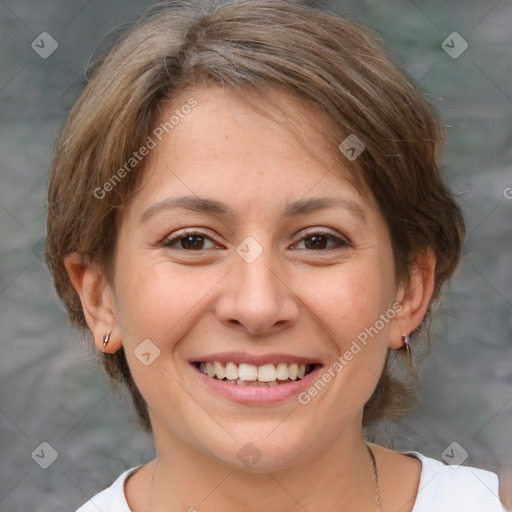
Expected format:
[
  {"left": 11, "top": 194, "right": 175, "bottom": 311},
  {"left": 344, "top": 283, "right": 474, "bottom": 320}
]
[{"left": 191, "top": 365, "right": 322, "bottom": 405}]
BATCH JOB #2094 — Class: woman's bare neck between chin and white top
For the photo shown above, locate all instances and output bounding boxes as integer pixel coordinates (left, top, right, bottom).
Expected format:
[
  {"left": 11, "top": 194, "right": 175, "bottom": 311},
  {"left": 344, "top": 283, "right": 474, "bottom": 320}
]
[{"left": 140, "top": 424, "right": 377, "bottom": 512}]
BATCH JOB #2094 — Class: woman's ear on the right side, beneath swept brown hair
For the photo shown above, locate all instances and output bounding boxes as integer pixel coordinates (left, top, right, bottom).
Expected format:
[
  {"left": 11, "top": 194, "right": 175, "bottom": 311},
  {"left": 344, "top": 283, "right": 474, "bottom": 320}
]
[{"left": 389, "top": 250, "right": 436, "bottom": 349}]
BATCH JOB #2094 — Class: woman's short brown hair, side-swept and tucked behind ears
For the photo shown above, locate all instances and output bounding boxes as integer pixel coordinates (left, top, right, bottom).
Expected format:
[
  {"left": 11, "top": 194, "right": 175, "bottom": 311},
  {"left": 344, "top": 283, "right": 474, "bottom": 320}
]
[{"left": 46, "top": 0, "right": 464, "bottom": 431}]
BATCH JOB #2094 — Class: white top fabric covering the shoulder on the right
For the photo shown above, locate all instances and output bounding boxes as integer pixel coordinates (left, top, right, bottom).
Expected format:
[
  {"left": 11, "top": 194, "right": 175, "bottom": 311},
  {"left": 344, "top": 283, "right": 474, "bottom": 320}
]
[{"left": 403, "top": 451, "right": 504, "bottom": 512}]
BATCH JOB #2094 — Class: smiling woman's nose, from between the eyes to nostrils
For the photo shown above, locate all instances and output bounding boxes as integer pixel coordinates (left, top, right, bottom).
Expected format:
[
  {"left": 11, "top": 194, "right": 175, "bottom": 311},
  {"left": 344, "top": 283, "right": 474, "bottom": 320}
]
[{"left": 217, "top": 237, "right": 298, "bottom": 334}]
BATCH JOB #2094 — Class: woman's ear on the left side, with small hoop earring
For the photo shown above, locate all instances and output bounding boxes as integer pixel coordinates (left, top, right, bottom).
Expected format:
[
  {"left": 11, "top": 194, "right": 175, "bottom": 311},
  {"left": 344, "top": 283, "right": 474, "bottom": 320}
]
[{"left": 64, "top": 252, "right": 122, "bottom": 353}]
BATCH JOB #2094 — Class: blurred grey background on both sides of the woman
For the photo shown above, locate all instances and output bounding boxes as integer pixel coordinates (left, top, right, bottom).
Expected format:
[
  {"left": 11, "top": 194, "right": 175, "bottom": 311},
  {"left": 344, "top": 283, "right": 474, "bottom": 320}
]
[{"left": 0, "top": 0, "right": 512, "bottom": 512}]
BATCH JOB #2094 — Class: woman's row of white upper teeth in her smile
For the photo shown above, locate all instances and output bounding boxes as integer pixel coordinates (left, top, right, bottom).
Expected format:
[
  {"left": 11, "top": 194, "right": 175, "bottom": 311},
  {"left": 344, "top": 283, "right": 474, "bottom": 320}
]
[{"left": 199, "top": 361, "right": 306, "bottom": 382}]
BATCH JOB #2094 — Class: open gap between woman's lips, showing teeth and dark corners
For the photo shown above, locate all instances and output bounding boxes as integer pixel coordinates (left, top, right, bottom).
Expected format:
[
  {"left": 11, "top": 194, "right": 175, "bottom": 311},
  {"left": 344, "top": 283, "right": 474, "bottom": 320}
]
[{"left": 192, "top": 361, "right": 321, "bottom": 387}]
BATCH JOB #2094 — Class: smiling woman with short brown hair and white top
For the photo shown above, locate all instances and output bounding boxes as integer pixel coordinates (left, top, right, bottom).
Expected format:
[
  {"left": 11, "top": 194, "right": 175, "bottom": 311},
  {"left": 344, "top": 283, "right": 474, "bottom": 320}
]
[{"left": 47, "top": 1, "right": 502, "bottom": 512}]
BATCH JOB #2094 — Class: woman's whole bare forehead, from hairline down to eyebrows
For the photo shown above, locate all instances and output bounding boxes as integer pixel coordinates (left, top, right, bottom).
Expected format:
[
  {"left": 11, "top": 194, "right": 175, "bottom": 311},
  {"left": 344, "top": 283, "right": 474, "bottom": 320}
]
[{"left": 125, "top": 86, "right": 376, "bottom": 220}]
